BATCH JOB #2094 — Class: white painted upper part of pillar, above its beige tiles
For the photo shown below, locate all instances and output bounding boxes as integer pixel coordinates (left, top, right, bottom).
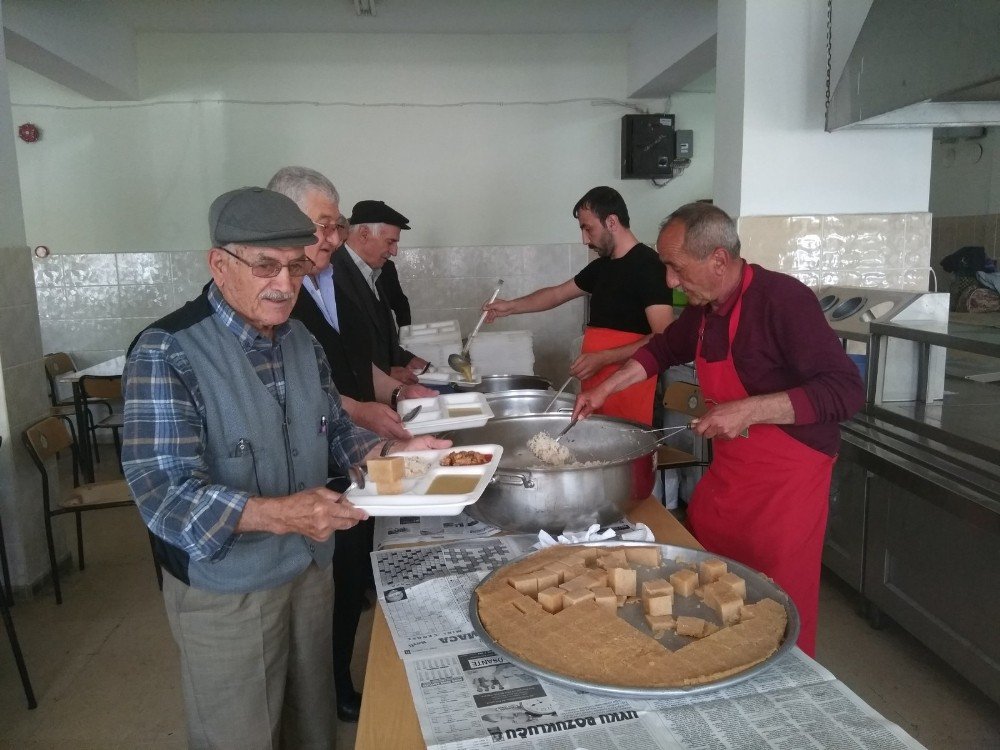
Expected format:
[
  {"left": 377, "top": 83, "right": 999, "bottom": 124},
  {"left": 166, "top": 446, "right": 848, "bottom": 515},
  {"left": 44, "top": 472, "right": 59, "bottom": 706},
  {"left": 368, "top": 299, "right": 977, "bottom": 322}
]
[{"left": 715, "top": 0, "right": 931, "bottom": 216}]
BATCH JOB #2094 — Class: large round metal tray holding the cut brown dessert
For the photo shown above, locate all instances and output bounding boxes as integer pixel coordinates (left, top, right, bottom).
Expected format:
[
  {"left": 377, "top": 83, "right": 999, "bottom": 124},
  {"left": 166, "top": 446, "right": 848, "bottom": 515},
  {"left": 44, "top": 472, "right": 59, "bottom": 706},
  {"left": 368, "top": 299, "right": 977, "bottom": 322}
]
[{"left": 469, "top": 540, "right": 799, "bottom": 700}]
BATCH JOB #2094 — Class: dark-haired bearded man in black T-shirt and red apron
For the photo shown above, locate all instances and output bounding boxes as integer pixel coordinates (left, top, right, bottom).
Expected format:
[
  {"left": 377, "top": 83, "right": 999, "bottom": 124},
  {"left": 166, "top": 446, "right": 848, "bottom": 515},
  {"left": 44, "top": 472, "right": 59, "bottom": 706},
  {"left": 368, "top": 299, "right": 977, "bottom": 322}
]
[{"left": 483, "top": 187, "right": 674, "bottom": 425}]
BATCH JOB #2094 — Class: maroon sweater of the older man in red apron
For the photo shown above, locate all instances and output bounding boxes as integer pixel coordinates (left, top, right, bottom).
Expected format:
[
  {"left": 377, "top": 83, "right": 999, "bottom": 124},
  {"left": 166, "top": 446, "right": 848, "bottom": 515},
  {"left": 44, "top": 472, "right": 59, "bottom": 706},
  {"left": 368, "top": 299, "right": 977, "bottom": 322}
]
[{"left": 634, "top": 265, "right": 865, "bottom": 456}]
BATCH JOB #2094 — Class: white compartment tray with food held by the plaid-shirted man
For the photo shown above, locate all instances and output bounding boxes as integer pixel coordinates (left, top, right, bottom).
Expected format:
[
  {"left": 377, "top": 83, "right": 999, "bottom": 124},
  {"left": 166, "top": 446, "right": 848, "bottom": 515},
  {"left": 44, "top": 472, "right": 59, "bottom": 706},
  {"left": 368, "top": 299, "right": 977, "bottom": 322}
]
[{"left": 347, "top": 445, "right": 503, "bottom": 516}]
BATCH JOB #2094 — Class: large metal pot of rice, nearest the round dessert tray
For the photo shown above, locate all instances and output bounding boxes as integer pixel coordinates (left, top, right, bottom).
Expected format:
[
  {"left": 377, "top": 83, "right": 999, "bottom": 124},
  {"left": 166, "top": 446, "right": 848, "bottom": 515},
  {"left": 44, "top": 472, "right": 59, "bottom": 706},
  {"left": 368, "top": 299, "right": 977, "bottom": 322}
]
[{"left": 451, "top": 414, "right": 657, "bottom": 533}]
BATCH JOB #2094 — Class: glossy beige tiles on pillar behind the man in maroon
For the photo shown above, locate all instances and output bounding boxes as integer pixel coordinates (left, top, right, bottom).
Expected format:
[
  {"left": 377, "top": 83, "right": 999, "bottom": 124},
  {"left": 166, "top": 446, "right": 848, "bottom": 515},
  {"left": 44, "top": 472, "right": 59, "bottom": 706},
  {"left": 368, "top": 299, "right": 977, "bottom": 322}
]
[{"left": 739, "top": 213, "right": 933, "bottom": 291}]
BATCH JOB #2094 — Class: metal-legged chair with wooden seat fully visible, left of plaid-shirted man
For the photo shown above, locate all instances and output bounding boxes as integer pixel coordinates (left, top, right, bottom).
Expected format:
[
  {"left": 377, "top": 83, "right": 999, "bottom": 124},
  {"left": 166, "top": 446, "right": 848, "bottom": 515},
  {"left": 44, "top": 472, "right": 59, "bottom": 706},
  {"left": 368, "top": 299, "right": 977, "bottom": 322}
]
[{"left": 22, "top": 417, "right": 133, "bottom": 604}]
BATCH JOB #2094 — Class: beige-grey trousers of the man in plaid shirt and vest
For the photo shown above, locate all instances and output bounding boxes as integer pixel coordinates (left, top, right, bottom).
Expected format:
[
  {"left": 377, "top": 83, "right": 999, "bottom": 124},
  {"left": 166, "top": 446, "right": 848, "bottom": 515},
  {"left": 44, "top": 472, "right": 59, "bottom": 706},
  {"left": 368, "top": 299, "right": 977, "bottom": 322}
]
[{"left": 163, "top": 563, "right": 336, "bottom": 750}]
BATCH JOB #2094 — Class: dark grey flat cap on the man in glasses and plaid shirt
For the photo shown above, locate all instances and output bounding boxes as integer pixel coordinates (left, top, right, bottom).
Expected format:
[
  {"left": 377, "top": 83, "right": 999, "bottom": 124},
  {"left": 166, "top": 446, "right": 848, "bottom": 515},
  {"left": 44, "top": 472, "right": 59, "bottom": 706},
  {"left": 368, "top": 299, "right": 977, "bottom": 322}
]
[{"left": 208, "top": 187, "right": 316, "bottom": 247}]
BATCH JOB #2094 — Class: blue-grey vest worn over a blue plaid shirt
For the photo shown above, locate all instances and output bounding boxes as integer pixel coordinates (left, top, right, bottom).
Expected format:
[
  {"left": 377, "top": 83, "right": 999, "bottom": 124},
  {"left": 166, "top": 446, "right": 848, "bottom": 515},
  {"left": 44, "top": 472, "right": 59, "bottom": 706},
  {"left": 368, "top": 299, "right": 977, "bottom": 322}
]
[{"left": 176, "top": 315, "right": 333, "bottom": 593}]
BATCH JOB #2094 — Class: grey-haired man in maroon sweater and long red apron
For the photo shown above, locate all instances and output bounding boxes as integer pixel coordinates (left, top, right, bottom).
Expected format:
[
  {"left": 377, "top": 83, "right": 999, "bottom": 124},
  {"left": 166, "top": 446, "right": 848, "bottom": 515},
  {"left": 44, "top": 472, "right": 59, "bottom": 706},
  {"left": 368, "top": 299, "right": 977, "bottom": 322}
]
[{"left": 575, "top": 203, "right": 865, "bottom": 656}]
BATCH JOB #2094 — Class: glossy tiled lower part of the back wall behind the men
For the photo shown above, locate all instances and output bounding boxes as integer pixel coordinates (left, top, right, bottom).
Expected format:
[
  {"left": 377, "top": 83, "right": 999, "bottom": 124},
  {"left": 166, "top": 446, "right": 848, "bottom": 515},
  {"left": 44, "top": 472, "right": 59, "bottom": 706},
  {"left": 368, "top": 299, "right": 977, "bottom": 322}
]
[{"left": 34, "top": 244, "right": 589, "bottom": 381}]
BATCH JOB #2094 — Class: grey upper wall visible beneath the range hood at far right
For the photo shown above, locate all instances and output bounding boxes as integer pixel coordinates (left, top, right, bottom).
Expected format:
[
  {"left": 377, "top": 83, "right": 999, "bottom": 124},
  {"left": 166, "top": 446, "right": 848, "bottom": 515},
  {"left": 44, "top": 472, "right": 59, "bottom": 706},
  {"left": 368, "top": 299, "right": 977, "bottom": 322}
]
[{"left": 931, "top": 128, "right": 1000, "bottom": 216}]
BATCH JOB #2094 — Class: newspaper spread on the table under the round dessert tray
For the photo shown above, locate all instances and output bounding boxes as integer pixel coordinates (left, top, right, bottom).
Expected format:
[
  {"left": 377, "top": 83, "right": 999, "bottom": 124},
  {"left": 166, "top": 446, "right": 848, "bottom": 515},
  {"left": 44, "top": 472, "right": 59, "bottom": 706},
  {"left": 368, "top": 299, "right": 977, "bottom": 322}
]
[{"left": 372, "top": 535, "right": 921, "bottom": 750}]
